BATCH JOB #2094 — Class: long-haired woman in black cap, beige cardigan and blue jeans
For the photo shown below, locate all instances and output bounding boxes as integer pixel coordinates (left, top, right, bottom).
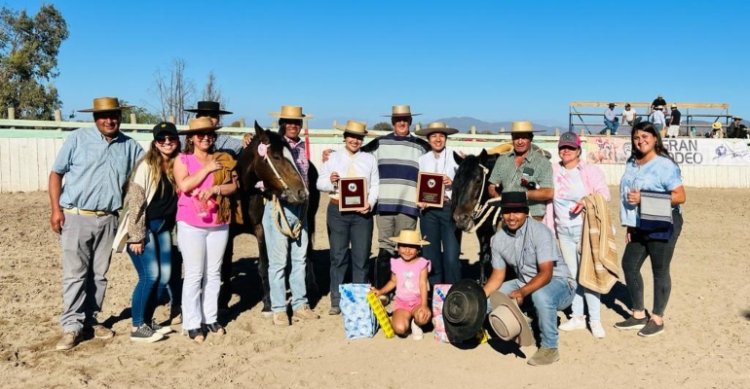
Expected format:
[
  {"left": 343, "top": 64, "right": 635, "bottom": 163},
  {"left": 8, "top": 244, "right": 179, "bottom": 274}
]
[{"left": 115, "top": 122, "right": 180, "bottom": 343}]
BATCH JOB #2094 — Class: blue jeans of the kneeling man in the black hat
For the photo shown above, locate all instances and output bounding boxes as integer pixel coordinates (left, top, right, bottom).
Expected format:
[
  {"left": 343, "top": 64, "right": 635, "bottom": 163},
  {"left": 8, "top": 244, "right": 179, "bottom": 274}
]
[{"left": 500, "top": 277, "right": 575, "bottom": 348}]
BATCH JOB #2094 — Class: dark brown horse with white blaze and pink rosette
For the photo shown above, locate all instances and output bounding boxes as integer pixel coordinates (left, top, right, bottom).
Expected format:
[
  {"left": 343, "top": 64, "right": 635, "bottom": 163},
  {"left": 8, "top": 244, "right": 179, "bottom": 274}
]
[{"left": 219, "top": 122, "right": 317, "bottom": 314}]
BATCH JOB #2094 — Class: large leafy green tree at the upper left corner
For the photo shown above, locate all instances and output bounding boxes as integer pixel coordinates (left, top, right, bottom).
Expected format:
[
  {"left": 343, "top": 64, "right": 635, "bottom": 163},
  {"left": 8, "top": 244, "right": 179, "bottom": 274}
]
[{"left": 0, "top": 4, "right": 68, "bottom": 119}]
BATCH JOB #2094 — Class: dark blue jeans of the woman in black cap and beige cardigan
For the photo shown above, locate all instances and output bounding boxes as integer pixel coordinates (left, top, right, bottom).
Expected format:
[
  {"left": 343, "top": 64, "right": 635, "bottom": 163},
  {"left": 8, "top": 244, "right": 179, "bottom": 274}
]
[{"left": 128, "top": 220, "right": 172, "bottom": 327}]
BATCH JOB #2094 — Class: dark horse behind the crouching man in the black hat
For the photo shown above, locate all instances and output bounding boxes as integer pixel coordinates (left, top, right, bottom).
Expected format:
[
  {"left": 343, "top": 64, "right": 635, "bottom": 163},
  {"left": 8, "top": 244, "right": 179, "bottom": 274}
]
[{"left": 452, "top": 150, "right": 499, "bottom": 283}]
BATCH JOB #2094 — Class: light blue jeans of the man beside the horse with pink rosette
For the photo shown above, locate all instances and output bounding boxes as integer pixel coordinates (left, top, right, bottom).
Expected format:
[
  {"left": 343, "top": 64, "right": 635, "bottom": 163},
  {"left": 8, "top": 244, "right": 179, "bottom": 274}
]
[{"left": 263, "top": 201, "right": 307, "bottom": 312}]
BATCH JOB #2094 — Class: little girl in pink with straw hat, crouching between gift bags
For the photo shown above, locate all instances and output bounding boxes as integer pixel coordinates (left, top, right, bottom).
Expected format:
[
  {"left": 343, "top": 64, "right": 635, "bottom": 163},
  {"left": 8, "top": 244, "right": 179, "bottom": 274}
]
[{"left": 373, "top": 230, "right": 432, "bottom": 340}]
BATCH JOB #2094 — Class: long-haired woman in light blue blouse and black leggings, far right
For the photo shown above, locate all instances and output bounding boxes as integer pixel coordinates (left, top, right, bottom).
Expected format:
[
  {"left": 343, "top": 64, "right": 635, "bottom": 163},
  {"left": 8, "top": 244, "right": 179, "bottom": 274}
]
[{"left": 615, "top": 122, "right": 685, "bottom": 337}]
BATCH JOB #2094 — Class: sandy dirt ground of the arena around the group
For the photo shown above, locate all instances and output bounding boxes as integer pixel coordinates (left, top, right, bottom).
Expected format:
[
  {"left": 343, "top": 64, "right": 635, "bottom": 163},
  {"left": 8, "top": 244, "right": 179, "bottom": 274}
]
[{"left": 0, "top": 188, "right": 750, "bottom": 388}]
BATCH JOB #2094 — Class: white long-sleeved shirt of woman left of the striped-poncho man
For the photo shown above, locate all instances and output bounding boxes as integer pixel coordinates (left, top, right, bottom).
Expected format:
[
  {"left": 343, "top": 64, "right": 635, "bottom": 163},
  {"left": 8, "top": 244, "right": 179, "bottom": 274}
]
[{"left": 316, "top": 148, "right": 380, "bottom": 209}]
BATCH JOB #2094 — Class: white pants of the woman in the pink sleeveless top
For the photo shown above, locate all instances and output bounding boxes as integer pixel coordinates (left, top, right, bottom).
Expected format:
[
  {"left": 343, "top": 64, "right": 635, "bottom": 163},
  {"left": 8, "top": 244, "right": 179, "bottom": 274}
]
[{"left": 177, "top": 221, "right": 229, "bottom": 330}]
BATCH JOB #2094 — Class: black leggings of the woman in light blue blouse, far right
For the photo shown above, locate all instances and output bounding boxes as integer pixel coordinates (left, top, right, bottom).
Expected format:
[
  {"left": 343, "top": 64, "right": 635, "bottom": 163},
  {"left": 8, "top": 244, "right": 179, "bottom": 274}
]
[{"left": 622, "top": 210, "right": 682, "bottom": 316}]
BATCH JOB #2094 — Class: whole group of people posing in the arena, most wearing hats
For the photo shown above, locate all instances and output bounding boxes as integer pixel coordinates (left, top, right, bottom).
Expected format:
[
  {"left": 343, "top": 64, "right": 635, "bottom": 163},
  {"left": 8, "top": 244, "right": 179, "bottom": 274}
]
[{"left": 49, "top": 98, "right": 685, "bottom": 365}]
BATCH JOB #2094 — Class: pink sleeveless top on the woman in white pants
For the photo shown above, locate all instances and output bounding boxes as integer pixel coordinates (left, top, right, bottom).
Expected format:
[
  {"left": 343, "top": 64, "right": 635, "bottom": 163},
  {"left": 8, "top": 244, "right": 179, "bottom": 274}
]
[{"left": 176, "top": 154, "right": 225, "bottom": 227}]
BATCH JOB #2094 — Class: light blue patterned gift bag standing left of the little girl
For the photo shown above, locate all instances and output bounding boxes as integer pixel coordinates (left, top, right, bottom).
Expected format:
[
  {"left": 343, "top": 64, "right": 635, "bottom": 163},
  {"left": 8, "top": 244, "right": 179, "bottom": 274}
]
[{"left": 339, "top": 284, "right": 378, "bottom": 339}]
